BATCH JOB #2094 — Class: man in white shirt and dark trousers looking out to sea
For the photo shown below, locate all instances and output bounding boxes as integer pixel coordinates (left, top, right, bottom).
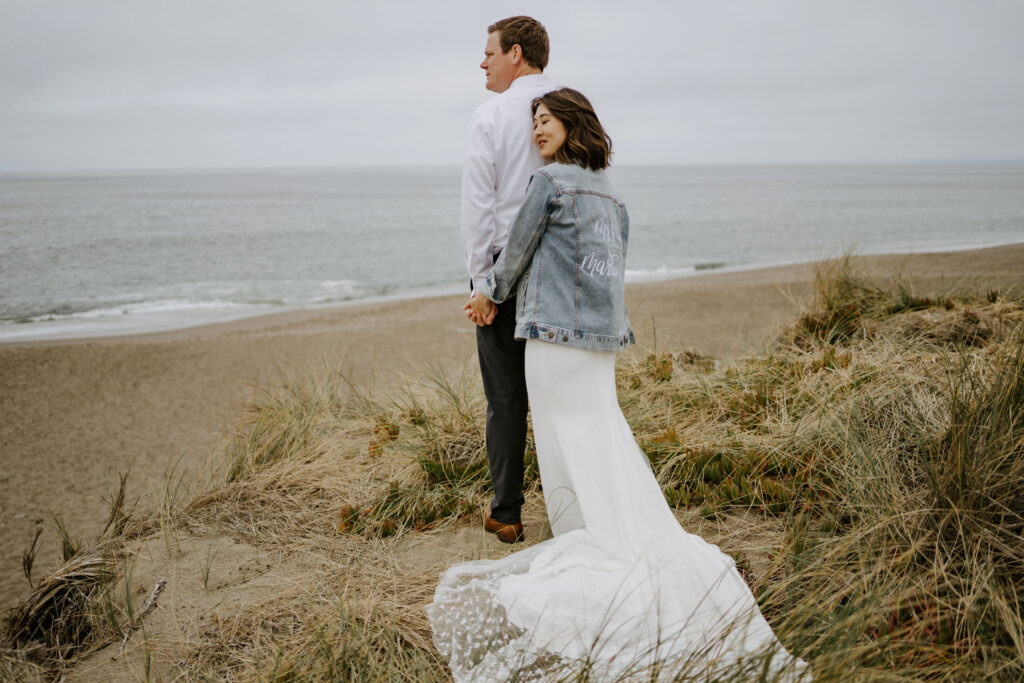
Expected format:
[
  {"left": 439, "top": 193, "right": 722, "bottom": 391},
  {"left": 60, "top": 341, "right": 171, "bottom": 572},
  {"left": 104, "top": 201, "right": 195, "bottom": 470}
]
[{"left": 461, "top": 16, "right": 554, "bottom": 543}]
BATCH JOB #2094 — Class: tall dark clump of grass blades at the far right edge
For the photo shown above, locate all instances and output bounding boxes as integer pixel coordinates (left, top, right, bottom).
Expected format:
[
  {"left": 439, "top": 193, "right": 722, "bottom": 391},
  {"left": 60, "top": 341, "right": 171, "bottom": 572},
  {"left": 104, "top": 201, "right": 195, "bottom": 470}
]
[{"left": 921, "top": 328, "right": 1024, "bottom": 659}]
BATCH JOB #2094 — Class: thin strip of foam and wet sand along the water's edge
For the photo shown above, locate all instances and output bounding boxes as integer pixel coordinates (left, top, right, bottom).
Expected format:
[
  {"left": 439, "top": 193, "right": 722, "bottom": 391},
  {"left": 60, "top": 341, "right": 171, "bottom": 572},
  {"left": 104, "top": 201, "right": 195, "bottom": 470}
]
[{"left": 0, "top": 240, "right": 1024, "bottom": 348}]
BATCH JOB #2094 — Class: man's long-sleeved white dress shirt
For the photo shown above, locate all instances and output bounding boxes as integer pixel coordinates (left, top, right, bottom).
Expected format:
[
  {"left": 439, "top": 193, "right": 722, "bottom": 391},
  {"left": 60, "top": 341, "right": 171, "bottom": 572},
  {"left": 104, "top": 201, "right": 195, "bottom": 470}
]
[{"left": 461, "top": 74, "right": 555, "bottom": 292}]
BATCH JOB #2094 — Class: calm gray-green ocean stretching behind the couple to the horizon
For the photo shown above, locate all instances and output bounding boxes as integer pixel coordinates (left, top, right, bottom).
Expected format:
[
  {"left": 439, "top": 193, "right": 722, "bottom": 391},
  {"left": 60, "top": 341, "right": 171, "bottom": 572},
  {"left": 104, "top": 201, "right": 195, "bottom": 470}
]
[{"left": 0, "top": 165, "right": 1024, "bottom": 341}]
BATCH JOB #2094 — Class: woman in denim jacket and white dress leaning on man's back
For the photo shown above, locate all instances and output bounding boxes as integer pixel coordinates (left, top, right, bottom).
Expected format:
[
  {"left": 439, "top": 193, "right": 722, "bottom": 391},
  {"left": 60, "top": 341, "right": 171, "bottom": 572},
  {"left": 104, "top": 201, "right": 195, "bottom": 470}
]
[{"left": 428, "top": 88, "right": 806, "bottom": 681}]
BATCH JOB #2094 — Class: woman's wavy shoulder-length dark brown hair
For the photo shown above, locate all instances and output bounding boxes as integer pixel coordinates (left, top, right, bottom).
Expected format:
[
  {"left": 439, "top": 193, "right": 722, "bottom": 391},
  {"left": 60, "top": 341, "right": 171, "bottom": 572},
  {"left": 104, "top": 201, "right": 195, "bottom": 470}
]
[{"left": 530, "top": 88, "right": 611, "bottom": 171}]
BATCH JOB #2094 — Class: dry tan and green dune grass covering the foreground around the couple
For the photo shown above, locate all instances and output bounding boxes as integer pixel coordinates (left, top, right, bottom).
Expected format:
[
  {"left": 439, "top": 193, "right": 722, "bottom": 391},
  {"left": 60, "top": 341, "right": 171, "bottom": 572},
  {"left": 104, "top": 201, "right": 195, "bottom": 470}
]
[{"left": 0, "top": 254, "right": 1024, "bottom": 681}]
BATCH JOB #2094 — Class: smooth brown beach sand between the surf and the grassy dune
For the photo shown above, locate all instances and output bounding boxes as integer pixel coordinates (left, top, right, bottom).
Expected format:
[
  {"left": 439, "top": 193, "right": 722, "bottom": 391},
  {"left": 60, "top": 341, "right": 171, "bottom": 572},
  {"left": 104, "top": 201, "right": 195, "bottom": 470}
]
[{"left": 0, "top": 244, "right": 1024, "bottom": 607}]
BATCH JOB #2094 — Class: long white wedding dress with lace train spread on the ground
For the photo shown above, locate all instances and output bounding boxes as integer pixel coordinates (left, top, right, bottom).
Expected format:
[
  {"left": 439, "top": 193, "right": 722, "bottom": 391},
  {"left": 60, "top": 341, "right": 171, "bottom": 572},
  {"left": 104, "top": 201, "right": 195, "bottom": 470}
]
[{"left": 427, "top": 341, "right": 810, "bottom": 682}]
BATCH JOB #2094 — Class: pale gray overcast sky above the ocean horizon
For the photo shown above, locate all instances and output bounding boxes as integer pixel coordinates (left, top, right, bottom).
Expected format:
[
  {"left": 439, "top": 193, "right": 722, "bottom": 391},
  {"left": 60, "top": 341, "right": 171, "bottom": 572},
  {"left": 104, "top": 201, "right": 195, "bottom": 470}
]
[{"left": 0, "top": 0, "right": 1024, "bottom": 172}]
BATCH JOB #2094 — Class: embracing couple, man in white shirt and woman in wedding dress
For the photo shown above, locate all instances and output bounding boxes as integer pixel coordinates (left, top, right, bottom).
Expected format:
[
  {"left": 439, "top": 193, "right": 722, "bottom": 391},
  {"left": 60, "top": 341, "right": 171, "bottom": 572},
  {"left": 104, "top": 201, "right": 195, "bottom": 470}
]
[{"left": 428, "top": 16, "right": 809, "bottom": 681}]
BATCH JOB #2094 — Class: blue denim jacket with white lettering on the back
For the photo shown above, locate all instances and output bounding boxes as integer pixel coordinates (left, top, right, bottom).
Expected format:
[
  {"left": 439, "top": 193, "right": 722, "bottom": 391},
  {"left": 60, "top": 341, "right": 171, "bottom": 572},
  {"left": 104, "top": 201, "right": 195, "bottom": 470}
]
[{"left": 480, "top": 163, "right": 635, "bottom": 351}]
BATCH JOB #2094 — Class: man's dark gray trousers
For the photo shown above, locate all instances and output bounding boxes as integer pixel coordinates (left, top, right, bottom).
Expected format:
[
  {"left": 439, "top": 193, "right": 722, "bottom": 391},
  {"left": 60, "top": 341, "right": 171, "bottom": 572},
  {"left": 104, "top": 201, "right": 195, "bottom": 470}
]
[{"left": 476, "top": 298, "right": 529, "bottom": 524}]
